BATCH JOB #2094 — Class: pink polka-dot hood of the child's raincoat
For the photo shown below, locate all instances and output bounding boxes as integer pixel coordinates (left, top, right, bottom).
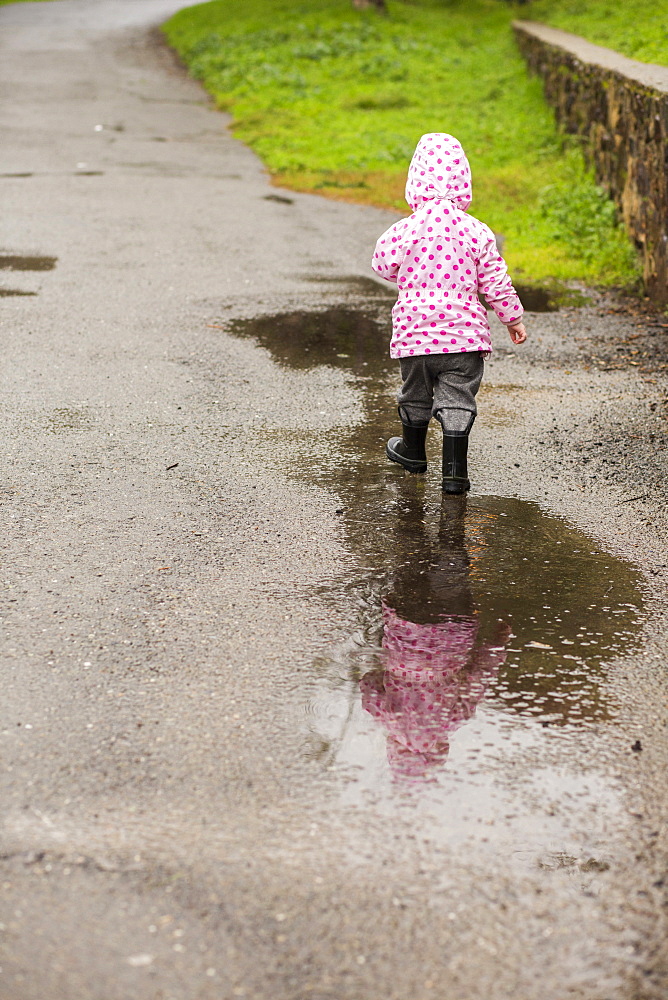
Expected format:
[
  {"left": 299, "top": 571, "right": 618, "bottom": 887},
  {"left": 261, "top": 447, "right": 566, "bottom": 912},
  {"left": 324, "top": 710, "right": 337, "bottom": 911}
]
[{"left": 406, "top": 132, "right": 472, "bottom": 212}]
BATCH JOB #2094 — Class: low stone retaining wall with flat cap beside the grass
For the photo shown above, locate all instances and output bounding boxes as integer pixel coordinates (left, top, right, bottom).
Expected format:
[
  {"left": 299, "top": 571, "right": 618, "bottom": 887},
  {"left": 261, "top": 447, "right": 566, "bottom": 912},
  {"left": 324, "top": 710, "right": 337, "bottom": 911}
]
[{"left": 513, "top": 21, "right": 668, "bottom": 306}]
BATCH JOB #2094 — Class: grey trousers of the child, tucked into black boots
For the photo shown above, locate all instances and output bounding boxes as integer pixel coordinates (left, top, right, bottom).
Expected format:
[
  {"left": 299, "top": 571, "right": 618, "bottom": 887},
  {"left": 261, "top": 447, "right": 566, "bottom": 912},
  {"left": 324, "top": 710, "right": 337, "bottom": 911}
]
[{"left": 397, "top": 351, "right": 485, "bottom": 434}]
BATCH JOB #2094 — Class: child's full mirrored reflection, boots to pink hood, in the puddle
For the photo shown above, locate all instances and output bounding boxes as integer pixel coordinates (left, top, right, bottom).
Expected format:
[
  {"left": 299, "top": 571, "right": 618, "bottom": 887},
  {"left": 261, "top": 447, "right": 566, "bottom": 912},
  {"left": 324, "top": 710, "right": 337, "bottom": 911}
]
[{"left": 360, "top": 498, "right": 510, "bottom": 777}]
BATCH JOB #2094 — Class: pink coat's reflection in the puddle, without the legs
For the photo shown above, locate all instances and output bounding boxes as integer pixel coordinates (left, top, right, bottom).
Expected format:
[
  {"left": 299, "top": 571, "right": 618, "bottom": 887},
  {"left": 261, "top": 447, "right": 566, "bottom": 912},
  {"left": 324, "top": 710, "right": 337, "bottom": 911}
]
[{"left": 360, "top": 607, "right": 506, "bottom": 777}]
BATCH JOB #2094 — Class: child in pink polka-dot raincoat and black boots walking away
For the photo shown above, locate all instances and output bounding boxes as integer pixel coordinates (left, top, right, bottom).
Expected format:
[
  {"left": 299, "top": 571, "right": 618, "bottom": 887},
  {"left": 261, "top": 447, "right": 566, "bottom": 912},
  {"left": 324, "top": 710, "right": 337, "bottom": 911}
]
[{"left": 372, "top": 132, "right": 526, "bottom": 493}]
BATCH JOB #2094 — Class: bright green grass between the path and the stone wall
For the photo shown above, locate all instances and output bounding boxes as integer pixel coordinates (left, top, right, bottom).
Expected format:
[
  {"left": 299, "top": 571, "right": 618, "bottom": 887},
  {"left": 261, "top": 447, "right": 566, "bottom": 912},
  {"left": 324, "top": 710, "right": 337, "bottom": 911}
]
[{"left": 165, "top": 0, "right": 649, "bottom": 287}]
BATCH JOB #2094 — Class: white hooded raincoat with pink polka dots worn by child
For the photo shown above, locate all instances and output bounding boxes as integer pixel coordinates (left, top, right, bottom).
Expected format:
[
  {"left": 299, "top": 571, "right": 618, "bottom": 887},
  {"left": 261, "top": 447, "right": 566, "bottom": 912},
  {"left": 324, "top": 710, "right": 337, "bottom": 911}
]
[{"left": 372, "top": 132, "right": 524, "bottom": 358}]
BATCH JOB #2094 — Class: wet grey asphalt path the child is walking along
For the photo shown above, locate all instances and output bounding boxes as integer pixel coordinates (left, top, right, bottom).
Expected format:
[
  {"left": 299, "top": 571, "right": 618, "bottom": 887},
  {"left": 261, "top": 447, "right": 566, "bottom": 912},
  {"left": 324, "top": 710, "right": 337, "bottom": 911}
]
[{"left": 0, "top": 0, "right": 668, "bottom": 1000}]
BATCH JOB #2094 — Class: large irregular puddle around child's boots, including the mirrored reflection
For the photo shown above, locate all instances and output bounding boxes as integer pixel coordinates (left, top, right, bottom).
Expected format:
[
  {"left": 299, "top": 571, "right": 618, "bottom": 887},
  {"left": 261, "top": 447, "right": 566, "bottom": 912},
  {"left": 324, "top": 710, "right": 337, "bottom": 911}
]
[{"left": 227, "top": 300, "right": 643, "bottom": 842}]
